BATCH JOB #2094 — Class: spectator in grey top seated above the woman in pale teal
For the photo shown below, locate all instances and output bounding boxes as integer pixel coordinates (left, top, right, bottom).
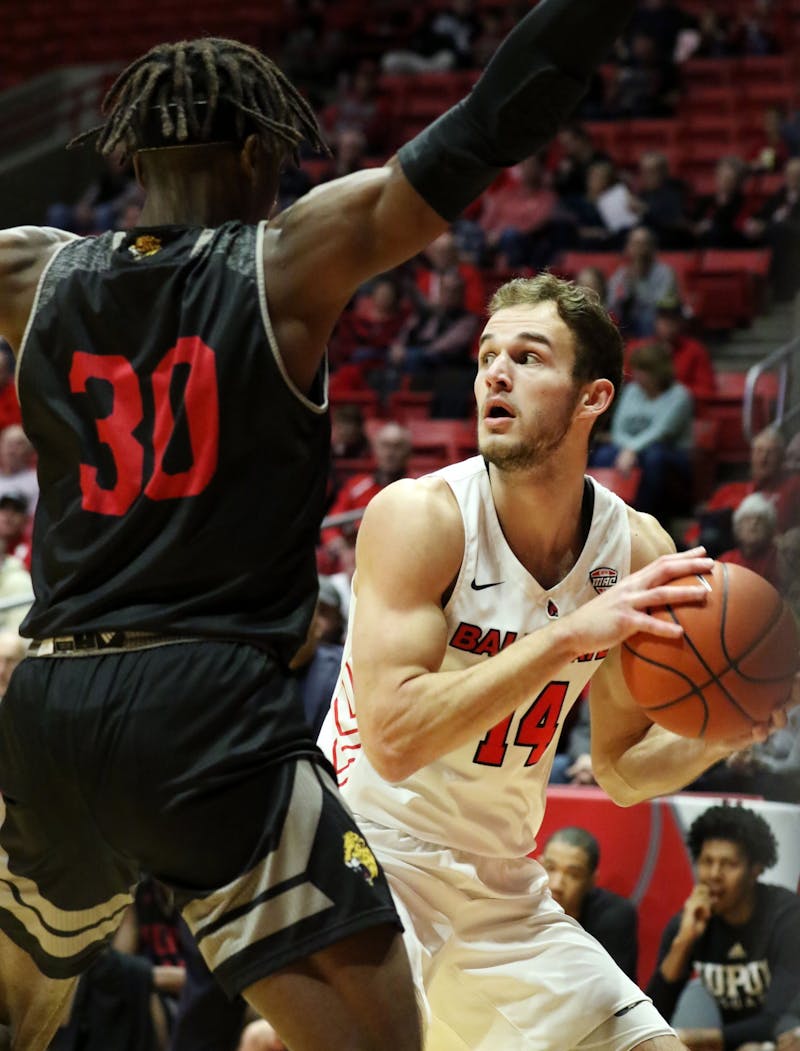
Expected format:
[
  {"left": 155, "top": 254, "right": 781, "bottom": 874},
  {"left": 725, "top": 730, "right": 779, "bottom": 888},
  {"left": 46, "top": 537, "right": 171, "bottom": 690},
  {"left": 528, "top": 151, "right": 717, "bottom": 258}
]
[{"left": 607, "top": 226, "right": 678, "bottom": 337}]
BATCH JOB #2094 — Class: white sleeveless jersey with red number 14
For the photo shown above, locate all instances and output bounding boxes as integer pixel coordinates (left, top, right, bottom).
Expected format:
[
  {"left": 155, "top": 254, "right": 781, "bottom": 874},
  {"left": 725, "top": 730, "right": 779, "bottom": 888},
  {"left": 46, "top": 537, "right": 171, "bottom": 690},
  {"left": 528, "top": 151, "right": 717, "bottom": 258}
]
[{"left": 319, "top": 456, "right": 631, "bottom": 858}]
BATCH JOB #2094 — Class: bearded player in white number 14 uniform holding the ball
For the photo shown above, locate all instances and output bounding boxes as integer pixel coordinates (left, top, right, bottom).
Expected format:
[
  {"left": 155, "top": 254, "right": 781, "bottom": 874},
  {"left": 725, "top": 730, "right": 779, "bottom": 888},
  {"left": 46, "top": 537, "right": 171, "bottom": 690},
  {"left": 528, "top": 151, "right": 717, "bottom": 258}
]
[{"left": 320, "top": 274, "right": 794, "bottom": 1051}]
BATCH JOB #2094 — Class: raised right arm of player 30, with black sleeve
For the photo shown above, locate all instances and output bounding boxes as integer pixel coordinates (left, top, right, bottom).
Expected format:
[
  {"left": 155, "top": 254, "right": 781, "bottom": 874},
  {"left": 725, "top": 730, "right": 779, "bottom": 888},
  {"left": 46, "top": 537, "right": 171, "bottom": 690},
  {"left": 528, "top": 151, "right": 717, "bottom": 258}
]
[{"left": 265, "top": 0, "right": 635, "bottom": 378}]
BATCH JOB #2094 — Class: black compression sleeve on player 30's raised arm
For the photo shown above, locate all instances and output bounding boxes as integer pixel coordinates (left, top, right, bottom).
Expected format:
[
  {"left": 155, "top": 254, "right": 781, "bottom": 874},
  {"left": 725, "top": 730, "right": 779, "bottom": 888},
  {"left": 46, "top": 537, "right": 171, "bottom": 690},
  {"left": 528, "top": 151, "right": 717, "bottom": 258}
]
[{"left": 397, "top": 0, "right": 636, "bottom": 220}]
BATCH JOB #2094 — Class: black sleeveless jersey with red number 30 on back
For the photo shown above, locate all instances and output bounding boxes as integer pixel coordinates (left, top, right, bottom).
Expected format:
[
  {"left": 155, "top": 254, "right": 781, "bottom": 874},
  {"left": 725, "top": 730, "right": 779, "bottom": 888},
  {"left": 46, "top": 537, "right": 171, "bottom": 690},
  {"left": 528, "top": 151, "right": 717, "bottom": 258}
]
[{"left": 18, "top": 223, "right": 330, "bottom": 659}]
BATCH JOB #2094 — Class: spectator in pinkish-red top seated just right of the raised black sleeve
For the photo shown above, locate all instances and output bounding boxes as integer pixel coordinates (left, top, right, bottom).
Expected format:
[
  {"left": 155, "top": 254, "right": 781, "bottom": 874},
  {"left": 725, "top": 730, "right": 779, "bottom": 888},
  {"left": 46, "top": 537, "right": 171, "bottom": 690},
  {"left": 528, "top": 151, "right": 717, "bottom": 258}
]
[{"left": 477, "top": 157, "right": 560, "bottom": 269}]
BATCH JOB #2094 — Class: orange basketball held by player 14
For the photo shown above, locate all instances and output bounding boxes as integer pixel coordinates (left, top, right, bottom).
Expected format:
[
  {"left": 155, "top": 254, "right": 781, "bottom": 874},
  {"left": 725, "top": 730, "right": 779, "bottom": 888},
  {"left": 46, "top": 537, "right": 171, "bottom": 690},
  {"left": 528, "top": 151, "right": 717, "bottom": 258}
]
[{"left": 621, "top": 562, "right": 800, "bottom": 741}]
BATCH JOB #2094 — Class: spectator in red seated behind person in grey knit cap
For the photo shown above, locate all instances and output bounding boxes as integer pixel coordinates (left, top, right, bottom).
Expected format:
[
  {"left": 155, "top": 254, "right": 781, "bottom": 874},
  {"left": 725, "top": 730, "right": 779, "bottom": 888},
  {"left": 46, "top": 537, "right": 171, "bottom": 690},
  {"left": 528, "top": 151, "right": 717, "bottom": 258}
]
[{"left": 685, "top": 427, "right": 800, "bottom": 558}]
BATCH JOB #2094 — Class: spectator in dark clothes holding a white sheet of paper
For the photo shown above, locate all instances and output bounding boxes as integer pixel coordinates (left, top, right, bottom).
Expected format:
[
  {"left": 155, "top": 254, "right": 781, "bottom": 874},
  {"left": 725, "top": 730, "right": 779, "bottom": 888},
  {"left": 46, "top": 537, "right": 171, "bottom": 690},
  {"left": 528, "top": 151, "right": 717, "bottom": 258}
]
[{"left": 567, "top": 161, "right": 638, "bottom": 251}]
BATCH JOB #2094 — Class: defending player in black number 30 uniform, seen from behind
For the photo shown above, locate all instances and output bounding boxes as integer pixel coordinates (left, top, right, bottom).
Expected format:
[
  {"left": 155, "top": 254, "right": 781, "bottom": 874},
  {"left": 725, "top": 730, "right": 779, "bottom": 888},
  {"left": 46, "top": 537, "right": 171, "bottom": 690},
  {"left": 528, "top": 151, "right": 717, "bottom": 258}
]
[{"left": 0, "top": 0, "right": 634, "bottom": 1051}]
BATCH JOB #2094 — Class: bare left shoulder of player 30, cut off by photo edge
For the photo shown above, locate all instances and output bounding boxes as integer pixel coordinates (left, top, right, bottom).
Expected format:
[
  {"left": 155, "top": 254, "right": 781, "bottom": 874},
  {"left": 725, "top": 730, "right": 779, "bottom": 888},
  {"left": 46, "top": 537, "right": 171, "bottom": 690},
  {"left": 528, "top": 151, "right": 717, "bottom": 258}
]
[{"left": 0, "top": 226, "right": 77, "bottom": 354}]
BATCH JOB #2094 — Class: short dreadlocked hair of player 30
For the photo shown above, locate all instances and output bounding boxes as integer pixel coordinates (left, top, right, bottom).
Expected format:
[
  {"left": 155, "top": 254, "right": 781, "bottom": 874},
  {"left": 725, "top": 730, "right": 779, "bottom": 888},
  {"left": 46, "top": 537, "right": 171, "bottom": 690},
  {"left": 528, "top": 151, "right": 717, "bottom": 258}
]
[{"left": 67, "top": 37, "right": 330, "bottom": 164}]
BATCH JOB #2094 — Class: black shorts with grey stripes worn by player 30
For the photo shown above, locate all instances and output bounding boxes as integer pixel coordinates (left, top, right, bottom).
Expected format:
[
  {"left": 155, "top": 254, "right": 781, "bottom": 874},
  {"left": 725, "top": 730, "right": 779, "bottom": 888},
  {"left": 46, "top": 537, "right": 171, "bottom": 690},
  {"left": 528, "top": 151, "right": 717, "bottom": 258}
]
[{"left": 0, "top": 641, "right": 399, "bottom": 995}]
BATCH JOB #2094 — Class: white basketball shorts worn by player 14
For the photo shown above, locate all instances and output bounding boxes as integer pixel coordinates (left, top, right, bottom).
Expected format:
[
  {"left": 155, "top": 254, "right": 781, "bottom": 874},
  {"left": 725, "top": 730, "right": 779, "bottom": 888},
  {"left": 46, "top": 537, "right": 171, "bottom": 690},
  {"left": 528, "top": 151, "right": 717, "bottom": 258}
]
[{"left": 365, "top": 818, "right": 674, "bottom": 1051}]
